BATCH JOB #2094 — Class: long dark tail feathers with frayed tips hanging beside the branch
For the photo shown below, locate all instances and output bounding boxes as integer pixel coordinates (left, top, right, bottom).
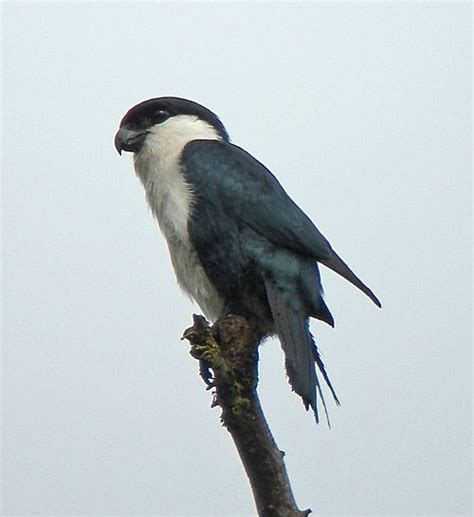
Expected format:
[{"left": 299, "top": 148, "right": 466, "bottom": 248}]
[{"left": 265, "top": 282, "right": 339, "bottom": 426}]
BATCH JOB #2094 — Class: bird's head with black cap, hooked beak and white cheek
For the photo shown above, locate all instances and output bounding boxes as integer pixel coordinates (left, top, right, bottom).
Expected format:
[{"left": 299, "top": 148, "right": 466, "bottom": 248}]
[{"left": 115, "top": 97, "right": 228, "bottom": 154}]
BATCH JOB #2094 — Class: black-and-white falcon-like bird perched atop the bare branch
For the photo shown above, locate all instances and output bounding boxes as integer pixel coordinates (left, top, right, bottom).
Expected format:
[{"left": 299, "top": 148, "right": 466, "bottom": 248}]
[{"left": 114, "top": 97, "right": 381, "bottom": 423}]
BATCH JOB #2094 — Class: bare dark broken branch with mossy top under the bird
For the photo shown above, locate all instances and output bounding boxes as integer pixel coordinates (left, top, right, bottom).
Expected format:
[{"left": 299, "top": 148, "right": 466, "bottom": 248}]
[{"left": 183, "top": 315, "right": 311, "bottom": 517}]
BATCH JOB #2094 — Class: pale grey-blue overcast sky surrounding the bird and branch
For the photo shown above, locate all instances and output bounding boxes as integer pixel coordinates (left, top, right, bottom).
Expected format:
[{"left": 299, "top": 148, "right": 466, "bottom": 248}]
[{"left": 2, "top": 2, "right": 472, "bottom": 515}]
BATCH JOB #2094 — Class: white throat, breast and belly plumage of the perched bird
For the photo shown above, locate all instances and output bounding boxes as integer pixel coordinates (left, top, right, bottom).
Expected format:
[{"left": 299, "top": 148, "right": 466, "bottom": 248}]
[{"left": 134, "top": 115, "right": 223, "bottom": 320}]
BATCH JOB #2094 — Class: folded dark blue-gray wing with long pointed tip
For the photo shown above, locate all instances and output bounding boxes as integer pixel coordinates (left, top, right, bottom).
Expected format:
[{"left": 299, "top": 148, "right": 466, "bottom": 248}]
[{"left": 182, "top": 140, "right": 380, "bottom": 306}]
